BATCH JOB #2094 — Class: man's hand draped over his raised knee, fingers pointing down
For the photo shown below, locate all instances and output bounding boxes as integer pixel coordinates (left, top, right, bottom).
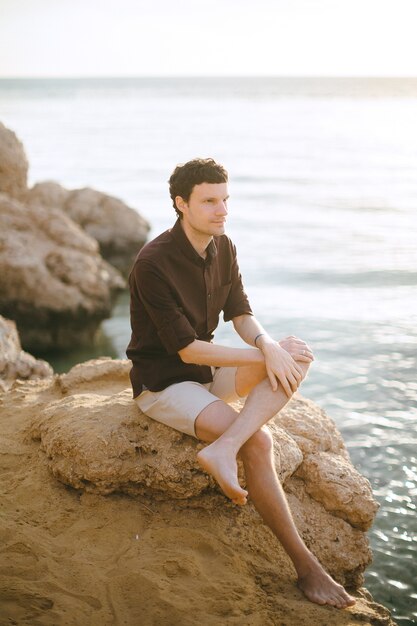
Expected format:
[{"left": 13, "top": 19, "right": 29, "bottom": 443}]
[{"left": 260, "top": 339, "right": 303, "bottom": 398}]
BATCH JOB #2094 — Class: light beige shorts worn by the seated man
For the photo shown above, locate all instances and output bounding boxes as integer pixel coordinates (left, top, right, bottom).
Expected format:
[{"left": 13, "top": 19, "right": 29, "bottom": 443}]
[{"left": 135, "top": 367, "right": 241, "bottom": 437}]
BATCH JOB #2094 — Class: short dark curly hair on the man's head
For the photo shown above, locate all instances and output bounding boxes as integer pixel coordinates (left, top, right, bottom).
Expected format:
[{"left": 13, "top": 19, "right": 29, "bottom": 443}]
[{"left": 168, "top": 158, "right": 229, "bottom": 219}]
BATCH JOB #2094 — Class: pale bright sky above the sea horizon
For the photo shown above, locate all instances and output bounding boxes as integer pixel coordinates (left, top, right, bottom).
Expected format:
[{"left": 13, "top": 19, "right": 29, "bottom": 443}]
[{"left": 0, "top": 0, "right": 417, "bottom": 77}]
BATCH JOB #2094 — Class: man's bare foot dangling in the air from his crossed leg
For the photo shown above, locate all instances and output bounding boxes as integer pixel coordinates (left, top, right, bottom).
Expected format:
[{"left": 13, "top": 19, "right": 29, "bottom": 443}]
[{"left": 197, "top": 444, "right": 248, "bottom": 505}]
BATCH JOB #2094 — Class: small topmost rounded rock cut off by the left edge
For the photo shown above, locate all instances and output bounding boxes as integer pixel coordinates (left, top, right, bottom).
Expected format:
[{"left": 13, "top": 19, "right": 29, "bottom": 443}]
[{"left": 0, "top": 122, "right": 29, "bottom": 198}]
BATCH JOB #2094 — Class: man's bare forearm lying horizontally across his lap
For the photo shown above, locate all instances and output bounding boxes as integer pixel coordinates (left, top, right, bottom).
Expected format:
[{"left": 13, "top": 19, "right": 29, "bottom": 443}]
[{"left": 178, "top": 339, "right": 264, "bottom": 367}]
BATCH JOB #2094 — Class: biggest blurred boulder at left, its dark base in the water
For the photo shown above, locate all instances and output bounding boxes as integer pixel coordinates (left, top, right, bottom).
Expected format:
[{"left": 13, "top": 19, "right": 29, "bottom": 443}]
[{"left": 0, "top": 194, "right": 124, "bottom": 350}]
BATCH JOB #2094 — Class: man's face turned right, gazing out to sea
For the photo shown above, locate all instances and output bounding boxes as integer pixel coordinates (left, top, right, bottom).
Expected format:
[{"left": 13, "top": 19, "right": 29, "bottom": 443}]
[{"left": 177, "top": 183, "right": 229, "bottom": 235}]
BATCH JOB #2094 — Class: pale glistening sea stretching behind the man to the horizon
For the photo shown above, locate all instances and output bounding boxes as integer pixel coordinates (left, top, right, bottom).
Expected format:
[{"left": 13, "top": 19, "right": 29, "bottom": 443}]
[{"left": 0, "top": 77, "right": 417, "bottom": 626}]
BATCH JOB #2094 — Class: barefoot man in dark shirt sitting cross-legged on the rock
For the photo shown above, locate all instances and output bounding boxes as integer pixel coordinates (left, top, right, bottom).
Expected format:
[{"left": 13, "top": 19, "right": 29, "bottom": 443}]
[{"left": 127, "top": 159, "right": 354, "bottom": 608}]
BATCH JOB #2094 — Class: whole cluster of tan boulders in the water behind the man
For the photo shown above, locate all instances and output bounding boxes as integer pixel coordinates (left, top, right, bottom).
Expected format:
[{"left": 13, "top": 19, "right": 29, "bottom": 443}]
[{"left": 0, "top": 123, "right": 149, "bottom": 352}]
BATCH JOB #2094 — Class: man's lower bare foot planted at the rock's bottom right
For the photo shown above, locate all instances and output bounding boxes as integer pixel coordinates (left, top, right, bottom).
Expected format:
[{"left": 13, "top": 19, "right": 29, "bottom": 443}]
[{"left": 297, "top": 561, "right": 356, "bottom": 609}]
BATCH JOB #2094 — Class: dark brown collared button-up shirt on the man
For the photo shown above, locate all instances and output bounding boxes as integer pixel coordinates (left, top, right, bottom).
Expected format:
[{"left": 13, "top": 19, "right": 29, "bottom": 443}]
[{"left": 126, "top": 219, "right": 252, "bottom": 397}]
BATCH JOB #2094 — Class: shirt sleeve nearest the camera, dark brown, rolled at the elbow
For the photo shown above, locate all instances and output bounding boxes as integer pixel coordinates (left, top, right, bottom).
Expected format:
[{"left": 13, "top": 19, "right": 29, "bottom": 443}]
[{"left": 131, "top": 261, "right": 196, "bottom": 354}]
